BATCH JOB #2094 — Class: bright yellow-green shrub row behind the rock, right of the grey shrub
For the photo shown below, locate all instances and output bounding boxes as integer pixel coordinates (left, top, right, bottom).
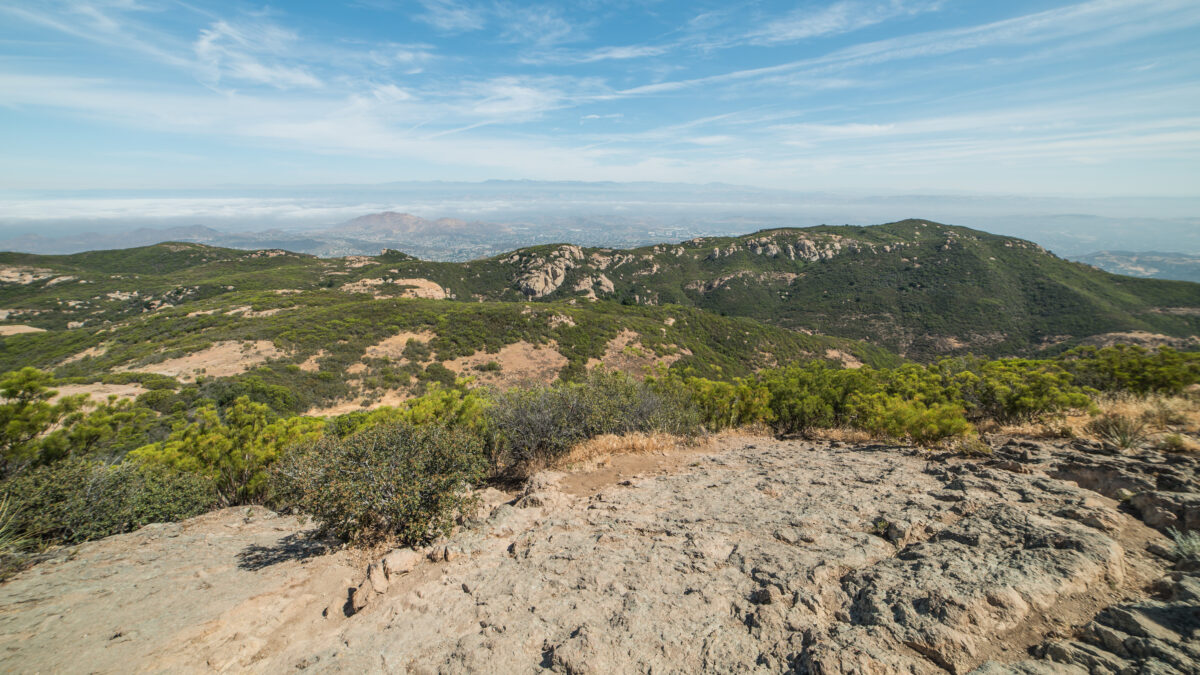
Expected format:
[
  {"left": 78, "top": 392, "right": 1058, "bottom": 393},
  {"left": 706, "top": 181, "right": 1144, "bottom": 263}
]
[{"left": 652, "top": 358, "right": 1094, "bottom": 444}]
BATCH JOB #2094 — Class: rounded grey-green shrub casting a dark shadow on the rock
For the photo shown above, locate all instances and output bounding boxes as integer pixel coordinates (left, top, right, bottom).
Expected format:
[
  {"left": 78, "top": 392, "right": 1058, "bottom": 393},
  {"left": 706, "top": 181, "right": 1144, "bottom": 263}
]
[{"left": 272, "top": 422, "right": 487, "bottom": 545}]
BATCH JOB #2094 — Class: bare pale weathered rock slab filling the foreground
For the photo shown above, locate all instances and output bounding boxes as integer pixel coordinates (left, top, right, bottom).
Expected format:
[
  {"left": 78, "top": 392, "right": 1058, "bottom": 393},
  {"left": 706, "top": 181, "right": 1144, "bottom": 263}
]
[{"left": 0, "top": 438, "right": 1200, "bottom": 674}]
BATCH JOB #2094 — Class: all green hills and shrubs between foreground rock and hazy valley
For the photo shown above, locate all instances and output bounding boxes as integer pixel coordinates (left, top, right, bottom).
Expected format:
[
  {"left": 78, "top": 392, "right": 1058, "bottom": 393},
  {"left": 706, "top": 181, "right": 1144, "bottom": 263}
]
[{"left": 0, "top": 221, "right": 1200, "bottom": 578}]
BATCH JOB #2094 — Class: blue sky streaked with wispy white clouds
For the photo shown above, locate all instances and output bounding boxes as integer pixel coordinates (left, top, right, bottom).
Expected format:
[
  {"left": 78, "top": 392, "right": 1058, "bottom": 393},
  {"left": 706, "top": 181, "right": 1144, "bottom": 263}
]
[{"left": 0, "top": 0, "right": 1200, "bottom": 197}]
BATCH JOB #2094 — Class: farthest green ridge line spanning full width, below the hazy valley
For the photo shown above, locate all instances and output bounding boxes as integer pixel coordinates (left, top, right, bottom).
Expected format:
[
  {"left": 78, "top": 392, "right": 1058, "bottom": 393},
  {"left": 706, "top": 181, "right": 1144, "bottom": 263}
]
[{"left": 0, "top": 220, "right": 1200, "bottom": 360}]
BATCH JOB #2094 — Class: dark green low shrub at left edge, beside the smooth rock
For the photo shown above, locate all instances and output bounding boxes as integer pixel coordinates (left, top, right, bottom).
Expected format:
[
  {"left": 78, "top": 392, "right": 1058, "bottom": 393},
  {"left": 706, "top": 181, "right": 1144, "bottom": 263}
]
[{"left": 0, "top": 459, "right": 216, "bottom": 543}]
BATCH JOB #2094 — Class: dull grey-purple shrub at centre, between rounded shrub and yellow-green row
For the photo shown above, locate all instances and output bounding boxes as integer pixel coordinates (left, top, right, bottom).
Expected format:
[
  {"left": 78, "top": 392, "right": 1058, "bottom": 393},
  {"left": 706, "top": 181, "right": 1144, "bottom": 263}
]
[{"left": 488, "top": 371, "right": 701, "bottom": 471}]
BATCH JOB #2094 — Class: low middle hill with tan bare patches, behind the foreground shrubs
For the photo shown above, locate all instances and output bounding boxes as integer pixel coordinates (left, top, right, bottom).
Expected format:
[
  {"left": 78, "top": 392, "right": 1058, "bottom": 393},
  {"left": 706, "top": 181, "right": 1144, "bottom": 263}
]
[{"left": 0, "top": 289, "right": 898, "bottom": 412}]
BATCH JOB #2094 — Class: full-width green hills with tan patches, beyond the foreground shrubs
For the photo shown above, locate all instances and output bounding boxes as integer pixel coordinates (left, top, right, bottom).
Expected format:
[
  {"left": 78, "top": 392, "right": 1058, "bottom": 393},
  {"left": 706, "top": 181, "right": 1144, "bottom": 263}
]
[{"left": 0, "top": 220, "right": 1200, "bottom": 407}]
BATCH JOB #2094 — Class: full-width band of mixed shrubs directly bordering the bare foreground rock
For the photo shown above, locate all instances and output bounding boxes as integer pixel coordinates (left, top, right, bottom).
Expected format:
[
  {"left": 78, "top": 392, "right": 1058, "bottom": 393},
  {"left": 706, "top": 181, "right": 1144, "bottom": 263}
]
[{"left": 0, "top": 347, "right": 1200, "bottom": 552}]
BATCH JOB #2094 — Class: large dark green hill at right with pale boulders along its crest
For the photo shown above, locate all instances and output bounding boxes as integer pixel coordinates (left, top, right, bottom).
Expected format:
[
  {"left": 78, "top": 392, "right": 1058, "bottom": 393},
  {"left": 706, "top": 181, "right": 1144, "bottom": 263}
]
[{"left": 422, "top": 220, "right": 1200, "bottom": 359}]
